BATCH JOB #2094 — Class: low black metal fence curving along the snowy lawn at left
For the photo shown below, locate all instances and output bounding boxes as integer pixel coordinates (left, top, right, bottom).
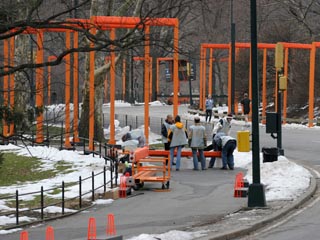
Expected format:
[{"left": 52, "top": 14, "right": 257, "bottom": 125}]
[{"left": 0, "top": 139, "right": 119, "bottom": 229}]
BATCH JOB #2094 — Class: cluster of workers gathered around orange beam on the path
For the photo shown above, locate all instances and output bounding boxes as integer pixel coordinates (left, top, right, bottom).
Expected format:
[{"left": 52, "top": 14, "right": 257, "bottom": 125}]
[{"left": 161, "top": 115, "right": 237, "bottom": 171}]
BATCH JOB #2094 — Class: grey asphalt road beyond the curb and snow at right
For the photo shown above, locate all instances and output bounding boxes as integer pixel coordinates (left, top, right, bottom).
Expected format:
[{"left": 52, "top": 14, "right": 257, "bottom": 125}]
[{"left": 104, "top": 107, "right": 320, "bottom": 240}]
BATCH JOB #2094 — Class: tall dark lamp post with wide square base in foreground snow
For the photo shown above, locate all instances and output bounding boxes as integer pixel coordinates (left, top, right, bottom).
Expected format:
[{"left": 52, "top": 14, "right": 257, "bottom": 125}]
[{"left": 248, "top": 0, "right": 266, "bottom": 207}]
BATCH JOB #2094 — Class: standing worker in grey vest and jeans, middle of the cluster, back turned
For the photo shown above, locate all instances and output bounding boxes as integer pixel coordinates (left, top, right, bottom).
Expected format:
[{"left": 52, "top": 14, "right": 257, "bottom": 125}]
[{"left": 188, "top": 117, "right": 207, "bottom": 170}]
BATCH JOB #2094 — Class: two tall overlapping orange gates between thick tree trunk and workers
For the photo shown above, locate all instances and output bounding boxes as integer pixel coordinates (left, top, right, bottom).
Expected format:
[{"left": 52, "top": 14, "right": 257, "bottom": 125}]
[{"left": 70, "top": 16, "right": 179, "bottom": 150}]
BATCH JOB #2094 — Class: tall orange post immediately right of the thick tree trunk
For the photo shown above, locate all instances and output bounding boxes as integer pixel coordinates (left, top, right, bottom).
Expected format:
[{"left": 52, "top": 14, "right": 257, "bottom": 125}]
[{"left": 109, "top": 28, "right": 116, "bottom": 144}]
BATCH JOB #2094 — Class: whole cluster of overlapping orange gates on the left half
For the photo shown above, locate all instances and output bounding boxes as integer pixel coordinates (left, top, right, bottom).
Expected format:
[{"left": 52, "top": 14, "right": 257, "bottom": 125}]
[{"left": 3, "top": 16, "right": 179, "bottom": 150}]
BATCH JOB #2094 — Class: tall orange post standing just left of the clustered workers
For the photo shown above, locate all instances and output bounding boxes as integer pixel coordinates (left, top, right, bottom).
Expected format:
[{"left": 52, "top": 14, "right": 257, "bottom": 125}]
[{"left": 144, "top": 25, "right": 150, "bottom": 144}]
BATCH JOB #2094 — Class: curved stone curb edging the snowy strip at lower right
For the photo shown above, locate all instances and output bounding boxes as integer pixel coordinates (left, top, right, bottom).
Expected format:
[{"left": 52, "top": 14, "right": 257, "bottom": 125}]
[{"left": 199, "top": 166, "right": 317, "bottom": 240}]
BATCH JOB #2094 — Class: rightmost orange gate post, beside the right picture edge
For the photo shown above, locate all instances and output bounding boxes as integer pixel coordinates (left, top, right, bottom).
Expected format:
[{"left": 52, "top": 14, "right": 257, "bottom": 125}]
[{"left": 308, "top": 42, "right": 316, "bottom": 127}]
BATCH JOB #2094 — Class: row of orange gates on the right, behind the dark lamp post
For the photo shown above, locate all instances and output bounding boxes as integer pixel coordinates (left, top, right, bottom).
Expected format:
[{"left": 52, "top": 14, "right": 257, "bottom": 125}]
[{"left": 200, "top": 42, "right": 320, "bottom": 127}]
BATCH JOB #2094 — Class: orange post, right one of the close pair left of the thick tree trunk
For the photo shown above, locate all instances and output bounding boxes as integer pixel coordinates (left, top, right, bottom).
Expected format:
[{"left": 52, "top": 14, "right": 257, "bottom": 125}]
[{"left": 73, "top": 31, "right": 80, "bottom": 142}]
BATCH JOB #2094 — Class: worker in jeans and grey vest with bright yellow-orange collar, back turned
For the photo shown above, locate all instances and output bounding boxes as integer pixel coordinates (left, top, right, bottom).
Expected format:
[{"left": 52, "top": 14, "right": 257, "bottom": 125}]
[{"left": 168, "top": 115, "right": 188, "bottom": 171}]
